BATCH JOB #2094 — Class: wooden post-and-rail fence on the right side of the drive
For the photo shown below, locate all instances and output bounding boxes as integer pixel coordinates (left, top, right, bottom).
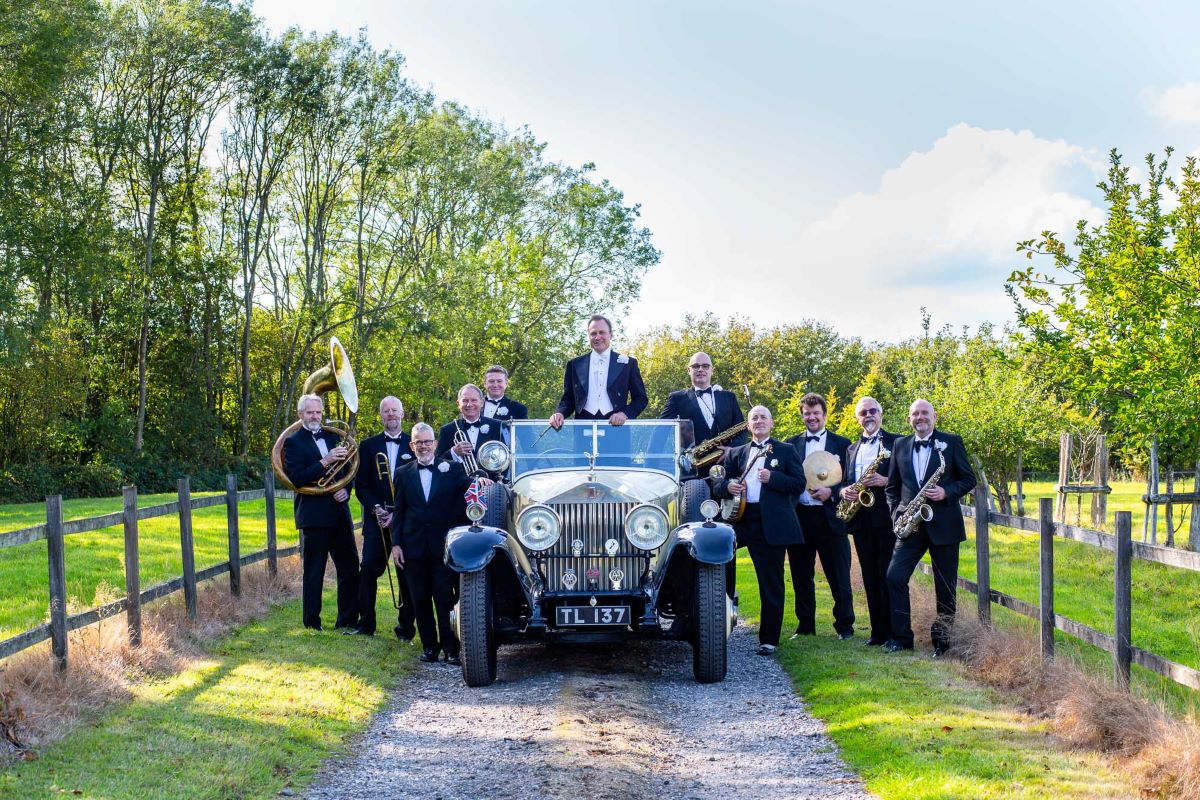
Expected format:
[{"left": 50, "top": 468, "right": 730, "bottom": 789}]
[{"left": 920, "top": 488, "right": 1200, "bottom": 691}]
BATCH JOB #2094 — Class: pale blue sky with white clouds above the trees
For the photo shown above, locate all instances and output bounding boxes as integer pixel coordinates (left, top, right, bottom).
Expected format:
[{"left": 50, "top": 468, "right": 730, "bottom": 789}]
[{"left": 254, "top": 0, "right": 1200, "bottom": 343}]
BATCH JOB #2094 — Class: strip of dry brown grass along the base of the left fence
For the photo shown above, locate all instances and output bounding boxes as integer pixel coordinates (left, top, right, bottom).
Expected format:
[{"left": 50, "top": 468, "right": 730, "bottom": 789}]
[{"left": 0, "top": 557, "right": 300, "bottom": 758}]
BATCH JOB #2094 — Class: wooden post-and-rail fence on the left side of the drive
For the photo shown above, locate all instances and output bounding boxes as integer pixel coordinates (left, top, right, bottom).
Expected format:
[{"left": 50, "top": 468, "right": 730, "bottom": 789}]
[{"left": 0, "top": 474, "right": 307, "bottom": 669}]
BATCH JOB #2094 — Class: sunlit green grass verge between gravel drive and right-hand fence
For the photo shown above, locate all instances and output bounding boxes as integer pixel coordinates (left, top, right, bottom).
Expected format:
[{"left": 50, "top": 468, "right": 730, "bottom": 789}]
[{"left": 738, "top": 551, "right": 1136, "bottom": 800}]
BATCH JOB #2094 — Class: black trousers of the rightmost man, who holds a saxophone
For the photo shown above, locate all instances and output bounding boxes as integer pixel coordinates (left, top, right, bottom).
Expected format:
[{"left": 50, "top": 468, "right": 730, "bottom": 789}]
[{"left": 888, "top": 529, "right": 959, "bottom": 650}]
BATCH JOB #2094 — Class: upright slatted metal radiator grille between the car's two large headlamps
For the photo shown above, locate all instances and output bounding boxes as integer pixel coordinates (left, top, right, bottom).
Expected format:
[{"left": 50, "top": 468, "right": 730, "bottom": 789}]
[{"left": 546, "top": 503, "right": 646, "bottom": 591}]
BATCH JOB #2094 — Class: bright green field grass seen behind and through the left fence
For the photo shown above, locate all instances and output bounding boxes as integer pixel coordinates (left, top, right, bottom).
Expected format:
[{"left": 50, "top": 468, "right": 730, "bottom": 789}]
[{"left": 0, "top": 493, "right": 296, "bottom": 639}]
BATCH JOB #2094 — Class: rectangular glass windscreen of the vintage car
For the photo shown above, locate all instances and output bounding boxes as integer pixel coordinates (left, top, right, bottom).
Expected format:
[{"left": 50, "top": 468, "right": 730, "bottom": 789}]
[{"left": 512, "top": 420, "right": 691, "bottom": 477}]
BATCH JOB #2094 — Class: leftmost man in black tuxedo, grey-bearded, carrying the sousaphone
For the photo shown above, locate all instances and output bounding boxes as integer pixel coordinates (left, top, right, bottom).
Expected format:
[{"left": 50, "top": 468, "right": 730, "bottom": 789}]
[{"left": 283, "top": 395, "right": 359, "bottom": 631}]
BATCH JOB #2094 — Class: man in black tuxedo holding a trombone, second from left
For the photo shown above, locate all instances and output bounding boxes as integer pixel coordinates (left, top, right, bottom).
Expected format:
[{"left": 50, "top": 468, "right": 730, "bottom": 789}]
[{"left": 348, "top": 396, "right": 416, "bottom": 642}]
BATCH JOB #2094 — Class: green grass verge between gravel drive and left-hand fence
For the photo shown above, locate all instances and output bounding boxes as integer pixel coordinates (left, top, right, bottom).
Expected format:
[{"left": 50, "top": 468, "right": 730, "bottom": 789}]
[{"left": 0, "top": 582, "right": 418, "bottom": 800}]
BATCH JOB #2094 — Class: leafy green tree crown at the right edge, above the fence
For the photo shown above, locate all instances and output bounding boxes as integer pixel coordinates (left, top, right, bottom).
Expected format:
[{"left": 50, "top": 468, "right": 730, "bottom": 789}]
[{"left": 1007, "top": 150, "right": 1200, "bottom": 470}]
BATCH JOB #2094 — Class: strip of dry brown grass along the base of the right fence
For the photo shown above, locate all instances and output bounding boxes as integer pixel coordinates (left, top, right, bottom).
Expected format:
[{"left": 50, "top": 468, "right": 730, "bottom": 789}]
[{"left": 945, "top": 609, "right": 1200, "bottom": 800}]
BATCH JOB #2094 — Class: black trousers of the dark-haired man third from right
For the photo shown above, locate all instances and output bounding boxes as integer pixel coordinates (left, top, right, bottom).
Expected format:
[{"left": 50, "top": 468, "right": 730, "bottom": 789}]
[{"left": 787, "top": 505, "right": 854, "bottom": 634}]
